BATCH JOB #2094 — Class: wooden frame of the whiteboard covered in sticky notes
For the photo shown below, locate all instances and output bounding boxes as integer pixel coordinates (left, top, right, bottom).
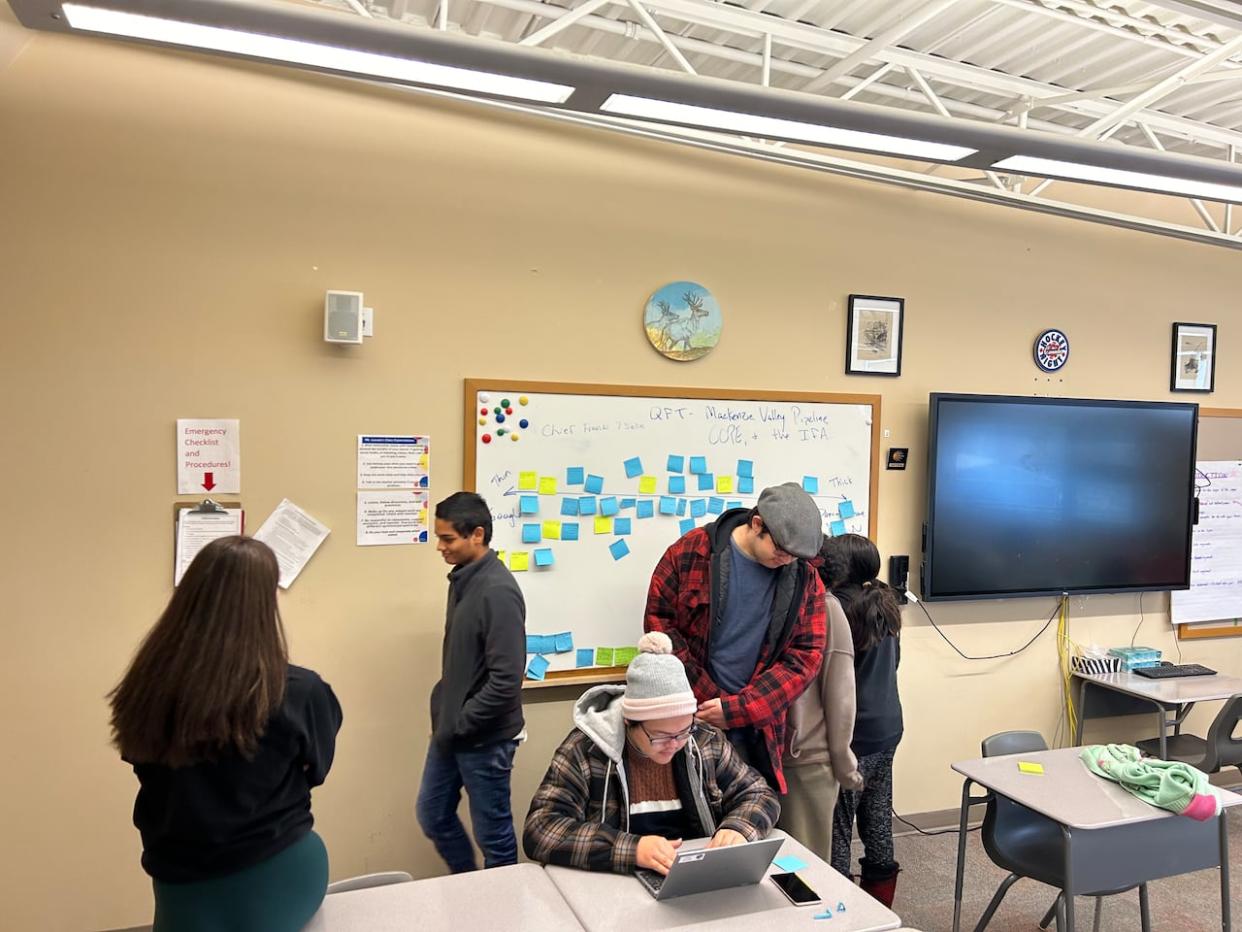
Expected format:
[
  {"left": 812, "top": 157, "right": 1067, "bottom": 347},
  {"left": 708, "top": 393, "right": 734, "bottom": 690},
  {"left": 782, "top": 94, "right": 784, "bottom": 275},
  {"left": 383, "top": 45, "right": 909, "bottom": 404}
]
[{"left": 462, "top": 379, "right": 884, "bottom": 688}]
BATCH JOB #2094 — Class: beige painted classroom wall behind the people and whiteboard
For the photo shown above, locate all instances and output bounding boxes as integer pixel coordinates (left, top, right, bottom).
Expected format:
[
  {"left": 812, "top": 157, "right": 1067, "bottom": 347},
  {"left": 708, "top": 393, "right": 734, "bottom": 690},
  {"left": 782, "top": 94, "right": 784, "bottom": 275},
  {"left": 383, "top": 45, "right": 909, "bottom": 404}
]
[{"left": 7, "top": 20, "right": 1242, "bottom": 930}]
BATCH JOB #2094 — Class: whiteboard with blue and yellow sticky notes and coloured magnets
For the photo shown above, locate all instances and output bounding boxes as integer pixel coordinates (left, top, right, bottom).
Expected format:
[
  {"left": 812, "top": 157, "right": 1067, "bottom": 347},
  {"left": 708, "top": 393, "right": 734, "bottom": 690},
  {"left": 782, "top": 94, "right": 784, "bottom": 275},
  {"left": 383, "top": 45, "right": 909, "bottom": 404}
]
[{"left": 465, "top": 379, "right": 879, "bottom": 678}]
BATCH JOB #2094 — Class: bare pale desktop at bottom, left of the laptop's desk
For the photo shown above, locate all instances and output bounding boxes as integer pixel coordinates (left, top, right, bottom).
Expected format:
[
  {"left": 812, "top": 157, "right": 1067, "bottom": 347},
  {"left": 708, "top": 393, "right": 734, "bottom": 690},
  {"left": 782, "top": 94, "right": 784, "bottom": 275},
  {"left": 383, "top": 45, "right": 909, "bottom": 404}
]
[{"left": 306, "top": 864, "right": 583, "bottom": 932}]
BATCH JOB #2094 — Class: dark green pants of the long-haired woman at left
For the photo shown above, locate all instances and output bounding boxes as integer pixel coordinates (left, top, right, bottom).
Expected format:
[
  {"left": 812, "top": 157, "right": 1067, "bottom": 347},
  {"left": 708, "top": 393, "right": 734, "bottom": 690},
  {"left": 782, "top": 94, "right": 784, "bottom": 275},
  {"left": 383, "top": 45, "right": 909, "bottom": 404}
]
[{"left": 153, "top": 831, "right": 328, "bottom": 932}]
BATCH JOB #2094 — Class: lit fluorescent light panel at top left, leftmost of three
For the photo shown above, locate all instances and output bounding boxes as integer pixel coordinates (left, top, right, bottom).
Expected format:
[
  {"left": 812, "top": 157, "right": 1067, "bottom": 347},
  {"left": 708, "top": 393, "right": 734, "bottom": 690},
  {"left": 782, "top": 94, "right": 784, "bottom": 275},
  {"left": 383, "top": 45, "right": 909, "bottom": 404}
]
[{"left": 61, "top": 4, "right": 574, "bottom": 103}]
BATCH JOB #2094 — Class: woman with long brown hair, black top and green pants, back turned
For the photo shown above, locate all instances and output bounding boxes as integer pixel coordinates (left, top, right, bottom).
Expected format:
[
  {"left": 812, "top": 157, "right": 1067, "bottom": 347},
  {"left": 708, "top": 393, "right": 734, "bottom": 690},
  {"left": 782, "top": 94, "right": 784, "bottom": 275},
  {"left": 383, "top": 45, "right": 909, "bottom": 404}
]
[{"left": 111, "top": 537, "right": 342, "bottom": 932}]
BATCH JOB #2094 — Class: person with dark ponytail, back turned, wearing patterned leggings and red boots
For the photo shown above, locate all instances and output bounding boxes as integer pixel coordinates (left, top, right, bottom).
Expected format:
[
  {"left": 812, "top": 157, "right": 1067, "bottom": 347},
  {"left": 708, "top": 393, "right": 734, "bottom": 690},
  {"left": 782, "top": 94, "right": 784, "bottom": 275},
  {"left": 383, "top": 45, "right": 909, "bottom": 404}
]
[{"left": 821, "top": 534, "right": 903, "bottom": 906}]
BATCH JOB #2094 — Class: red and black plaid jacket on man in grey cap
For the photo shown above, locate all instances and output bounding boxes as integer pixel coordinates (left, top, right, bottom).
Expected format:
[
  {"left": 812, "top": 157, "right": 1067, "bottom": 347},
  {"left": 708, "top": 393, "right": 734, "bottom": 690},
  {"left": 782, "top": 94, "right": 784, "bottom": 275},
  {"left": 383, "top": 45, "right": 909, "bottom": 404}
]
[{"left": 643, "top": 521, "right": 827, "bottom": 793}]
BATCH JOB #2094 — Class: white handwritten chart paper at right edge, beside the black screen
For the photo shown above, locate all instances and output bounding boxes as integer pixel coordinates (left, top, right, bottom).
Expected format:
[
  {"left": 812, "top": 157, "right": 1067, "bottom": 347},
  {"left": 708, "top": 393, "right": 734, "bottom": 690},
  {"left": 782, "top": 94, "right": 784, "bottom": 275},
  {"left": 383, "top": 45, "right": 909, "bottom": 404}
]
[{"left": 1172, "top": 460, "right": 1242, "bottom": 625}]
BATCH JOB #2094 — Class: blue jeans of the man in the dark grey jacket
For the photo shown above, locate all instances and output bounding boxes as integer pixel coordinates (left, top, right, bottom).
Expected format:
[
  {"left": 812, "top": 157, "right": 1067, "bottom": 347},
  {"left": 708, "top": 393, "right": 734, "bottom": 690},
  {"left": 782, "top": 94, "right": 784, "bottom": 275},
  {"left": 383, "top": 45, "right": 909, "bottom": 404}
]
[{"left": 417, "top": 741, "right": 518, "bottom": 874}]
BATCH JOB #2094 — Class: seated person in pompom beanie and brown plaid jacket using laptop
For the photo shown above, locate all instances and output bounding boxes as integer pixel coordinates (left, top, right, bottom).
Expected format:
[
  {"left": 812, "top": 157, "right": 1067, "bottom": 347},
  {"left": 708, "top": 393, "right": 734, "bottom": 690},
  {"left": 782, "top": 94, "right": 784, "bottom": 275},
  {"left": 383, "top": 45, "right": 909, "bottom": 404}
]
[{"left": 522, "top": 631, "right": 780, "bottom": 874}]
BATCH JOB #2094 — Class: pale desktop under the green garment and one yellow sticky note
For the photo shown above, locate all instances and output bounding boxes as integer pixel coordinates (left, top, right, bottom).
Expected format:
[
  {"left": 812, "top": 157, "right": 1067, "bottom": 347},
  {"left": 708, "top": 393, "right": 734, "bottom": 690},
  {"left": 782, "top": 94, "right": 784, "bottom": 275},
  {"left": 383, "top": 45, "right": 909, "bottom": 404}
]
[{"left": 953, "top": 748, "right": 1242, "bottom": 829}]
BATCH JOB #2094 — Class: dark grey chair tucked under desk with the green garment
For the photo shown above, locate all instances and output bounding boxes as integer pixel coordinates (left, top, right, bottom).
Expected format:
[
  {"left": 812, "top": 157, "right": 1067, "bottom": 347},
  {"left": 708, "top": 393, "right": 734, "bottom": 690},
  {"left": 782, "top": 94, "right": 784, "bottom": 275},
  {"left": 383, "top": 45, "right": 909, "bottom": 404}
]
[{"left": 975, "top": 732, "right": 1151, "bottom": 932}]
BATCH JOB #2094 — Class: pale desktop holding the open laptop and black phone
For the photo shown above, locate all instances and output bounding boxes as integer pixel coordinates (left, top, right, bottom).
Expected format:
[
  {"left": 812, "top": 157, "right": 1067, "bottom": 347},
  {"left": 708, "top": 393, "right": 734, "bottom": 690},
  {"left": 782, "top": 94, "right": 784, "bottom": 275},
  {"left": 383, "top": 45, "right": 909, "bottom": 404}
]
[{"left": 546, "top": 831, "right": 902, "bottom": 932}]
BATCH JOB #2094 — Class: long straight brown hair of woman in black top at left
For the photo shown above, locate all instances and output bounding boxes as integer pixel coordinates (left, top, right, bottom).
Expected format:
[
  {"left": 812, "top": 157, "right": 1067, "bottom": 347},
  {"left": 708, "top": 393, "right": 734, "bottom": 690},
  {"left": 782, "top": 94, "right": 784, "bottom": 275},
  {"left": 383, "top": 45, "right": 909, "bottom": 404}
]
[{"left": 108, "top": 537, "right": 288, "bottom": 767}]
